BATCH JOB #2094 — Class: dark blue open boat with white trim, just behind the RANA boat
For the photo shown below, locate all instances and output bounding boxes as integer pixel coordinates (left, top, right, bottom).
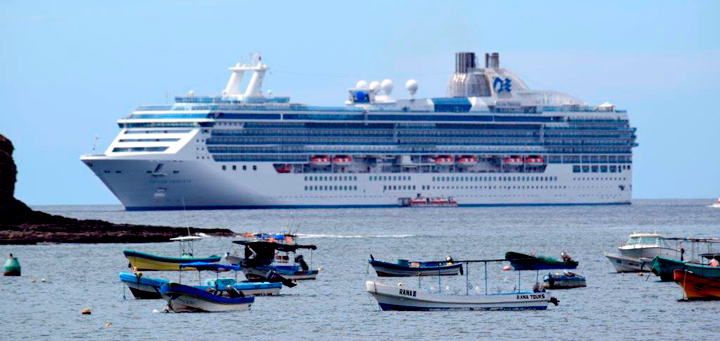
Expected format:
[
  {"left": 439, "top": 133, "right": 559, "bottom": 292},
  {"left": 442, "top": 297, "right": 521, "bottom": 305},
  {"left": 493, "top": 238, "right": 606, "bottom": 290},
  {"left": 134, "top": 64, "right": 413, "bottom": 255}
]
[{"left": 368, "top": 255, "right": 463, "bottom": 277}]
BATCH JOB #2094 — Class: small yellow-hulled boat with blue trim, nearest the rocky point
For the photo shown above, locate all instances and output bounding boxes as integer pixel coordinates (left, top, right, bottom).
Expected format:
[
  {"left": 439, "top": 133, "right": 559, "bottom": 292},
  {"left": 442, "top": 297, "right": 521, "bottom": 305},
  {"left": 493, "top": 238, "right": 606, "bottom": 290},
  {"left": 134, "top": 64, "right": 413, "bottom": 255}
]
[{"left": 123, "top": 236, "right": 222, "bottom": 271}]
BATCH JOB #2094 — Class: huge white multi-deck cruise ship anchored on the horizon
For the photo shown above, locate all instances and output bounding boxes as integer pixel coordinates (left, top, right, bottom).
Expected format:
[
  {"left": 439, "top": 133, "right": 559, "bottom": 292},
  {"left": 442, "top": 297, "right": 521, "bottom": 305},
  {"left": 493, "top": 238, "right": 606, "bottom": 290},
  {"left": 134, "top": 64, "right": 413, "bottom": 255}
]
[{"left": 80, "top": 52, "right": 637, "bottom": 210}]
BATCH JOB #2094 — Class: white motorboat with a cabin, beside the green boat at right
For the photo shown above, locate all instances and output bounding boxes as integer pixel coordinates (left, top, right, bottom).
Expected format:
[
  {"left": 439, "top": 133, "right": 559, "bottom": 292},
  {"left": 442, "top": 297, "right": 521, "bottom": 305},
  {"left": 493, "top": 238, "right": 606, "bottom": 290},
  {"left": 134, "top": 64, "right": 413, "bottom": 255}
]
[{"left": 605, "top": 233, "right": 682, "bottom": 272}]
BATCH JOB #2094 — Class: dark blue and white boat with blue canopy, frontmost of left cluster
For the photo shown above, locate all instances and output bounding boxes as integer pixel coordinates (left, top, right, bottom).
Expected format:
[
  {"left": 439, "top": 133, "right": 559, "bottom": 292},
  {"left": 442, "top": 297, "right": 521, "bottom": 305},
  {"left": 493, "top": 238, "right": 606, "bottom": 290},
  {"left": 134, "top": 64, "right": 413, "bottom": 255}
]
[{"left": 160, "top": 262, "right": 255, "bottom": 313}]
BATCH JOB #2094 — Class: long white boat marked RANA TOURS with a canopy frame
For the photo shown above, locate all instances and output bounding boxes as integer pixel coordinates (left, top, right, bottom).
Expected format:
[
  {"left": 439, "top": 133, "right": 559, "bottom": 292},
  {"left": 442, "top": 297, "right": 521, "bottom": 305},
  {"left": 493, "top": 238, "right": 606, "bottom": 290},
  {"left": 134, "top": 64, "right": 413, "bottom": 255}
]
[{"left": 365, "top": 259, "right": 558, "bottom": 311}]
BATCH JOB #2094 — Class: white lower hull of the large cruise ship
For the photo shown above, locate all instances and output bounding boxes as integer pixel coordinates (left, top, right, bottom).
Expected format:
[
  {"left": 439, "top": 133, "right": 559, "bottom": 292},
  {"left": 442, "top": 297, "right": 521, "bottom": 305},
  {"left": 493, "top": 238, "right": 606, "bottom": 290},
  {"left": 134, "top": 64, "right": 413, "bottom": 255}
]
[{"left": 84, "top": 157, "right": 632, "bottom": 210}]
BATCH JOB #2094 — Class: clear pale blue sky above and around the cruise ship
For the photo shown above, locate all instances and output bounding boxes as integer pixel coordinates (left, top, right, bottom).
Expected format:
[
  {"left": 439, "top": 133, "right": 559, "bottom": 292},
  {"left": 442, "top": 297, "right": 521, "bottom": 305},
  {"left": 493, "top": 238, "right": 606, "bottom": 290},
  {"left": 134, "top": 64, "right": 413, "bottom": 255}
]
[{"left": 0, "top": 0, "right": 720, "bottom": 204}]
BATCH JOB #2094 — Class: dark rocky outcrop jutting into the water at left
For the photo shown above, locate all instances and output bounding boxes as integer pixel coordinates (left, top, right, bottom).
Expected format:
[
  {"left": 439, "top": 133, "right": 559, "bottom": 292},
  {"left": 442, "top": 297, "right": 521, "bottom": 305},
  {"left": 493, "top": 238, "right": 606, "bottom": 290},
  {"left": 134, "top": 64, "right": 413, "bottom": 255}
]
[{"left": 0, "top": 135, "right": 233, "bottom": 244}]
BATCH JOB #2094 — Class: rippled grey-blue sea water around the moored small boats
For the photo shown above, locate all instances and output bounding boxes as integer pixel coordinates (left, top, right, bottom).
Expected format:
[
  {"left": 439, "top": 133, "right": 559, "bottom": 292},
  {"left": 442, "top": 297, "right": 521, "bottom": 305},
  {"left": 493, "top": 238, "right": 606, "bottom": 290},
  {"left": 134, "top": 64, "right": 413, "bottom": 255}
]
[{"left": 0, "top": 200, "right": 720, "bottom": 340}]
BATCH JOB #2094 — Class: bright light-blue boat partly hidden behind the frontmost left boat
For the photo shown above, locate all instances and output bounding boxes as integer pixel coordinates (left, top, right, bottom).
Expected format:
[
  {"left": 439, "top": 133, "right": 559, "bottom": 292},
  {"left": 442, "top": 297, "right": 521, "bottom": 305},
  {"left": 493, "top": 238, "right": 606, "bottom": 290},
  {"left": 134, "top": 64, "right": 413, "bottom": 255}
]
[{"left": 120, "top": 272, "right": 282, "bottom": 299}]
